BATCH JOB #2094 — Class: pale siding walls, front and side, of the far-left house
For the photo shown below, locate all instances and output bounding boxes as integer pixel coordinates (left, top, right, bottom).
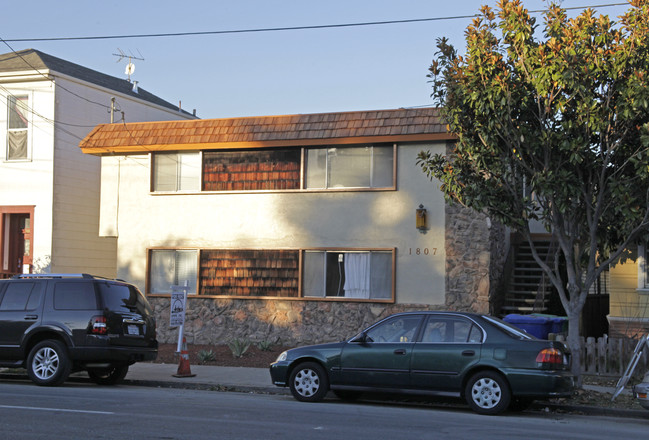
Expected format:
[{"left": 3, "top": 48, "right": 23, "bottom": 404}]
[{"left": 0, "top": 72, "right": 190, "bottom": 276}]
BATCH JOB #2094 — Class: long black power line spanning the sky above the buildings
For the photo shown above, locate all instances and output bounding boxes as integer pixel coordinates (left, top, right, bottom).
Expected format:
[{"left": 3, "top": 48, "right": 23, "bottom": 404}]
[{"left": 3, "top": 3, "right": 628, "bottom": 43}]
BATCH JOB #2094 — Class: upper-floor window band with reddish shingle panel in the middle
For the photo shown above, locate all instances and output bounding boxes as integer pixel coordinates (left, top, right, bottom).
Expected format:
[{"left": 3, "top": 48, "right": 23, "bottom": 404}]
[{"left": 152, "top": 145, "right": 396, "bottom": 192}]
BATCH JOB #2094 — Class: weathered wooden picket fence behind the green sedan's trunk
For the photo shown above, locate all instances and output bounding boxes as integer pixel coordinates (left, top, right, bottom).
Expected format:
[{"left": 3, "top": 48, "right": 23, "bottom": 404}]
[{"left": 556, "top": 335, "right": 649, "bottom": 377}]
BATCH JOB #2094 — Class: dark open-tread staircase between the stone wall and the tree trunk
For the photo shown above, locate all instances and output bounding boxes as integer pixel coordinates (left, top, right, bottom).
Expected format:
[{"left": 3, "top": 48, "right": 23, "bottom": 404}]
[{"left": 501, "top": 239, "right": 553, "bottom": 315}]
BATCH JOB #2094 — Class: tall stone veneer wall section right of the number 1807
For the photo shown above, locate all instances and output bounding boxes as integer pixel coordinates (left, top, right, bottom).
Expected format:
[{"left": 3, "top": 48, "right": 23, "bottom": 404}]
[{"left": 446, "top": 204, "right": 509, "bottom": 314}]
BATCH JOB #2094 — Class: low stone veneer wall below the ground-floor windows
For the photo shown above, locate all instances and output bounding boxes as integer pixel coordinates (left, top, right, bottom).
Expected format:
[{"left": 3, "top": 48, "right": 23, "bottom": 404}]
[{"left": 149, "top": 297, "right": 440, "bottom": 346}]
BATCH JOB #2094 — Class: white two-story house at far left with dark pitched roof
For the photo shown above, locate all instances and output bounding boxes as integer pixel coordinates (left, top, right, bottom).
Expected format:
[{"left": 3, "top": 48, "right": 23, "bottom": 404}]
[{"left": 0, "top": 49, "right": 194, "bottom": 277}]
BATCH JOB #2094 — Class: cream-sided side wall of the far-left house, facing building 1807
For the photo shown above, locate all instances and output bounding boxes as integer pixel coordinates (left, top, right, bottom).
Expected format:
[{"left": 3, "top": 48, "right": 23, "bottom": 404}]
[{"left": 52, "top": 78, "right": 191, "bottom": 277}]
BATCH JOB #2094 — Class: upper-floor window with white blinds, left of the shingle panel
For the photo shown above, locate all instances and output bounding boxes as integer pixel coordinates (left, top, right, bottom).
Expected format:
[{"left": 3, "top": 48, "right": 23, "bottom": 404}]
[{"left": 153, "top": 153, "right": 201, "bottom": 192}]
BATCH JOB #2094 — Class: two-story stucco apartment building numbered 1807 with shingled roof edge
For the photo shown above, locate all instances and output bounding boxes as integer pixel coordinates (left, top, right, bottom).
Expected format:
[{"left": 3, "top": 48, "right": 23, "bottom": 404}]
[{"left": 80, "top": 108, "right": 507, "bottom": 344}]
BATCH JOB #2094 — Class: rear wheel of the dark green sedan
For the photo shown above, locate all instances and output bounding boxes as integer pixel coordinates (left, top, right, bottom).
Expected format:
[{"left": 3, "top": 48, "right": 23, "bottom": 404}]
[{"left": 464, "top": 371, "right": 511, "bottom": 415}]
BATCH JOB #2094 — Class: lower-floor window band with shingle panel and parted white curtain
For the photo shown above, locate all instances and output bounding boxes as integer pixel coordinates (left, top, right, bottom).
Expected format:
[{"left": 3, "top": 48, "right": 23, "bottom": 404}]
[{"left": 147, "top": 249, "right": 394, "bottom": 301}]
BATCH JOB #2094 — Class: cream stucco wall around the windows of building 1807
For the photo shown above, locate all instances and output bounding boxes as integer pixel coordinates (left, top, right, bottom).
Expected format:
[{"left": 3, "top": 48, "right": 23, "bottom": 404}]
[{"left": 110, "top": 144, "right": 445, "bottom": 305}]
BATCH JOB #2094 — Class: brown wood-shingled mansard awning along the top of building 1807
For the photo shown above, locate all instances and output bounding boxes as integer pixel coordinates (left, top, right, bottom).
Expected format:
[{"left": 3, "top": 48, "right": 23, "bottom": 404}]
[{"left": 79, "top": 108, "right": 454, "bottom": 155}]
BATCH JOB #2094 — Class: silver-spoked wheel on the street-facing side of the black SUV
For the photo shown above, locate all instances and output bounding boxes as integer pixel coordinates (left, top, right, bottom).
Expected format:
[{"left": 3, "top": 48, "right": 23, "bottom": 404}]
[{"left": 27, "top": 339, "right": 72, "bottom": 386}]
